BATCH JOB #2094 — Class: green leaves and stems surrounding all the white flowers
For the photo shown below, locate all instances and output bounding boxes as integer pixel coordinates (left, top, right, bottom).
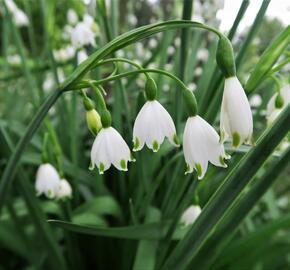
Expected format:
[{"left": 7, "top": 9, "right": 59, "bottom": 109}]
[{"left": 0, "top": 0, "right": 290, "bottom": 270}]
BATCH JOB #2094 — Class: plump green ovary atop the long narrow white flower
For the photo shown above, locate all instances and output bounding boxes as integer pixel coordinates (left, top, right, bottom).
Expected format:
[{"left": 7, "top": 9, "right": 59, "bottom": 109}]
[{"left": 216, "top": 36, "right": 236, "bottom": 78}]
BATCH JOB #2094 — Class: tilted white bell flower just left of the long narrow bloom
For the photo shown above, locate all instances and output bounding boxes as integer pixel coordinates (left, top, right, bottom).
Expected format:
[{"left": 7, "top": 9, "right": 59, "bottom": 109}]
[{"left": 183, "top": 115, "right": 230, "bottom": 179}]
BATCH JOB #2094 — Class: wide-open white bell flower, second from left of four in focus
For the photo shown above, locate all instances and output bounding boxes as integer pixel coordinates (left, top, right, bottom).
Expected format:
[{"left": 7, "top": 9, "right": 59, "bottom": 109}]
[{"left": 133, "top": 100, "right": 178, "bottom": 152}]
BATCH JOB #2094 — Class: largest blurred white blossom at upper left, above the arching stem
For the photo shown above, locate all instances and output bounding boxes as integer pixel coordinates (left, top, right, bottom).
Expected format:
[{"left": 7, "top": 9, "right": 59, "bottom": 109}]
[{"left": 71, "top": 22, "right": 96, "bottom": 48}]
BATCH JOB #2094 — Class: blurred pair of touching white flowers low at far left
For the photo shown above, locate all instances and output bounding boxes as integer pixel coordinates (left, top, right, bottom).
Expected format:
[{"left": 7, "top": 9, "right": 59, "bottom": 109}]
[{"left": 35, "top": 163, "right": 72, "bottom": 200}]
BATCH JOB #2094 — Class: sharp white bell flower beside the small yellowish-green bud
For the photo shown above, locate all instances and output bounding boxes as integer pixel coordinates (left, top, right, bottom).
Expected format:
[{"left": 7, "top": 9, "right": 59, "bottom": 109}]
[{"left": 90, "top": 127, "right": 134, "bottom": 174}]
